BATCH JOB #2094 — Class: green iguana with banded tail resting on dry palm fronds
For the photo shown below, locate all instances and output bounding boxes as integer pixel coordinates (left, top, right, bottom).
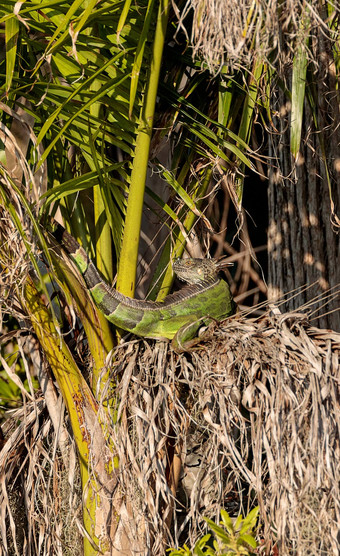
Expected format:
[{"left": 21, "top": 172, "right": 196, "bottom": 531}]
[{"left": 53, "top": 224, "right": 236, "bottom": 349}]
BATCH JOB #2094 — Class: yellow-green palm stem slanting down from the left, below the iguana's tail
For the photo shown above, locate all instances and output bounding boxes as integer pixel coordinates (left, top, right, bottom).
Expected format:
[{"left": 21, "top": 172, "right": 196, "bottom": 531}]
[{"left": 24, "top": 277, "right": 112, "bottom": 556}]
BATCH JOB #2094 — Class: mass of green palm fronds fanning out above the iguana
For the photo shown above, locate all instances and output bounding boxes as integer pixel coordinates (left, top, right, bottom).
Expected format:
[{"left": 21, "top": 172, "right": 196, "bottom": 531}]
[{"left": 0, "top": 0, "right": 255, "bottom": 283}]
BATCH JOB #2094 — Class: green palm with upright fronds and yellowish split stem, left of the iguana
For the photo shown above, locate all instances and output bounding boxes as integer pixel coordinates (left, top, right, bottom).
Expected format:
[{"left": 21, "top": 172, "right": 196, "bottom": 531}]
[{"left": 1, "top": 1, "right": 251, "bottom": 554}]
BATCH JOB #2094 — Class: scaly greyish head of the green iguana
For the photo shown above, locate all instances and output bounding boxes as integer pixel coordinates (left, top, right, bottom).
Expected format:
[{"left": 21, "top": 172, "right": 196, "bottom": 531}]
[{"left": 173, "top": 259, "right": 218, "bottom": 284}]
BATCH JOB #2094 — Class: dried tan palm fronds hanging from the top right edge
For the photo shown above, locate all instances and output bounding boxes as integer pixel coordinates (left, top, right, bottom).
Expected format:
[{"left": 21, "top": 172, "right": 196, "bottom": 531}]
[{"left": 180, "top": 0, "right": 339, "bottom": 74}]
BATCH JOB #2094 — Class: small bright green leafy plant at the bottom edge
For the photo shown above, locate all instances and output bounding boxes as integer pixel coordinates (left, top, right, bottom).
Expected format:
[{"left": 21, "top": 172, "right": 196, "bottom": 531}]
[{"left": 169, "top": 506, "right": 259, "bottom": 556}]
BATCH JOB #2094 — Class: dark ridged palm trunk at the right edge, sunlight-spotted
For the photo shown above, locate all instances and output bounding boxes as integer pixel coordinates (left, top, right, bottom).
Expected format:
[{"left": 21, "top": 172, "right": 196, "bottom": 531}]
[{"left": 268, "top": 25, "right": 340, "bottom": 330}]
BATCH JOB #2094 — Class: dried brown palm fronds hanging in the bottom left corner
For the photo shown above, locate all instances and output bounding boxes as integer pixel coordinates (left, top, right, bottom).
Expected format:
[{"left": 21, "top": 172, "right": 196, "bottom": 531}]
[{"left": 0, "top": 397, "right": 82, "bottom": 556}]
